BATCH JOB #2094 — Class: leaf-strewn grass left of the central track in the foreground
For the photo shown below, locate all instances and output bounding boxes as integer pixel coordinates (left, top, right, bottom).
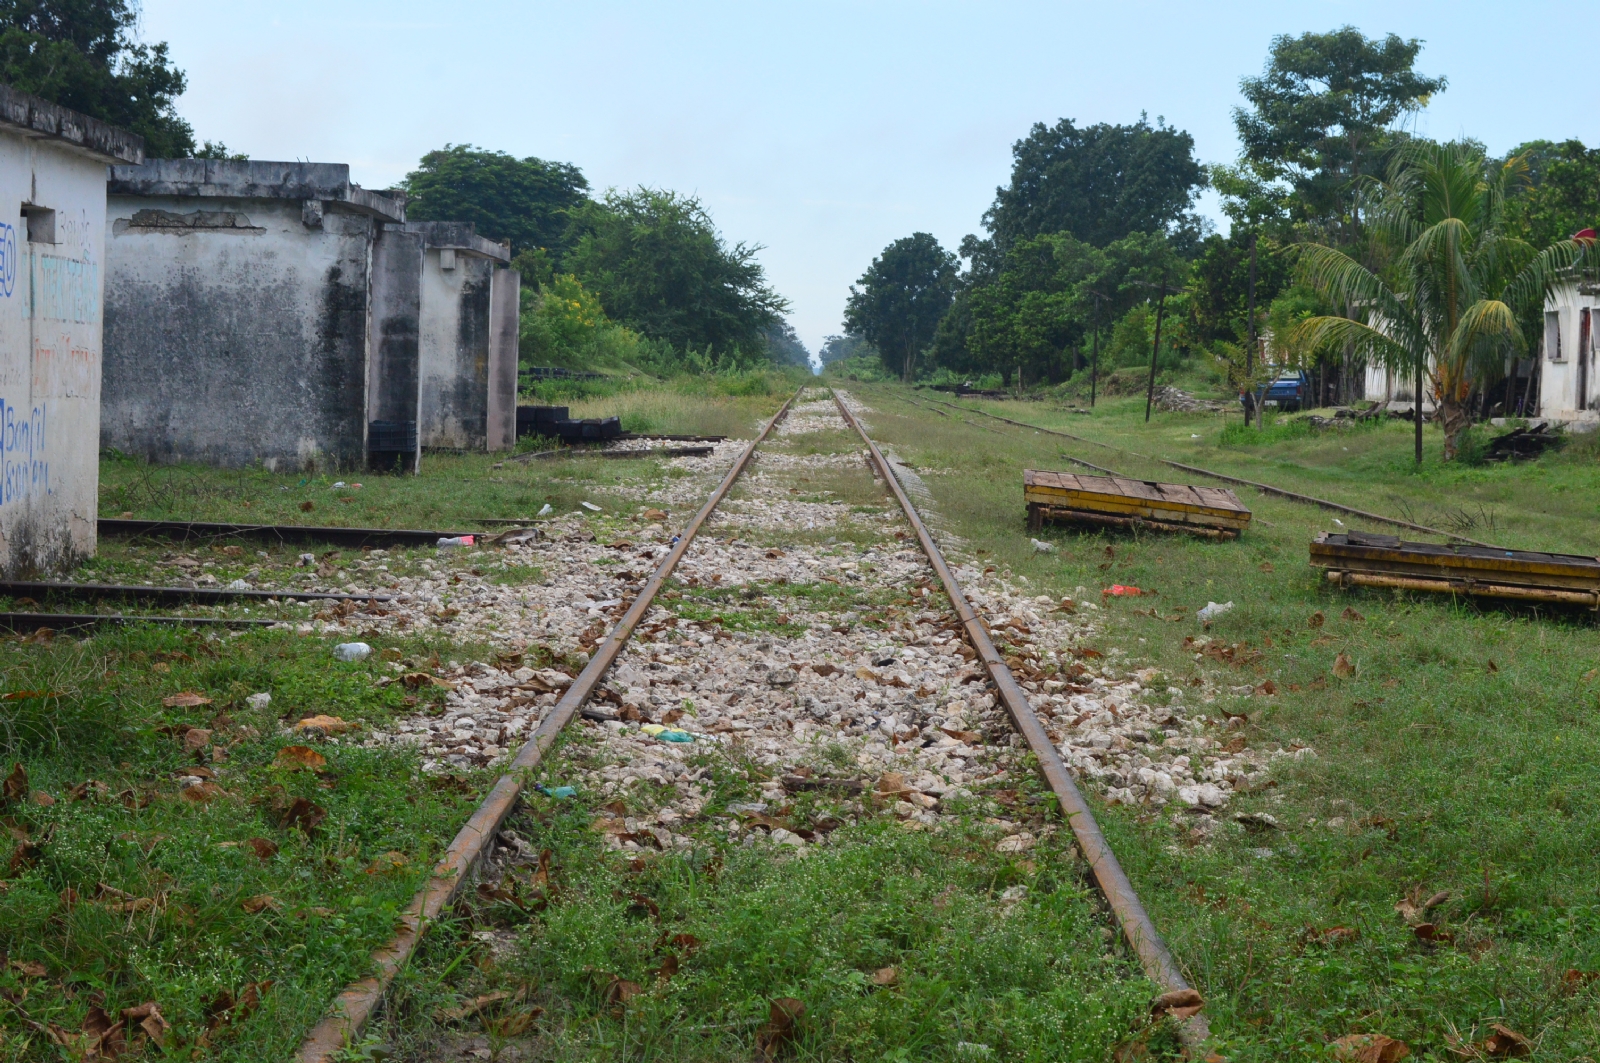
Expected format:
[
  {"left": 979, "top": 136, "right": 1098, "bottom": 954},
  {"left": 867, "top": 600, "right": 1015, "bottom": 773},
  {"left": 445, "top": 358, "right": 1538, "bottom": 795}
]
[{"left": 0, "top": 628, "right": 478, "bottom": 1061}]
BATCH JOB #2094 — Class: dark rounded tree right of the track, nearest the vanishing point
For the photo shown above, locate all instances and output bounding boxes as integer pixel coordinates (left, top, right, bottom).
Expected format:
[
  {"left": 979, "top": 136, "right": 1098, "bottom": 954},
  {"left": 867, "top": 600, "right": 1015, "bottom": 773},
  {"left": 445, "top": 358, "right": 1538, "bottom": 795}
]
[{"left": 845, "top": 232, "right": 955, "bottom": 383}]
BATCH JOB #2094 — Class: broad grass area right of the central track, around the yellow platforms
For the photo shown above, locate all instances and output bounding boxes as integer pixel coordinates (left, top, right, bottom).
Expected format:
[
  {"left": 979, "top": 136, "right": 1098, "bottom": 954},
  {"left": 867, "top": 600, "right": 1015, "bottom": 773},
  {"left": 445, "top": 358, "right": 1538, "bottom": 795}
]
[{"left": 856, "top": 377, "right": 1600, "bottom": 1063}]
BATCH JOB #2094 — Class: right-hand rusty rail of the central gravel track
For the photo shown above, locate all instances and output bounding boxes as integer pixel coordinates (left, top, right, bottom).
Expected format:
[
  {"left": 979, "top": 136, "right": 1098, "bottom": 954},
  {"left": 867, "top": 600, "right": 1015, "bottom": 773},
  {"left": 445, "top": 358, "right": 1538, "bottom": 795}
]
[{"left": 834, "top": 391, "right": 1210, "bottom": 1044}]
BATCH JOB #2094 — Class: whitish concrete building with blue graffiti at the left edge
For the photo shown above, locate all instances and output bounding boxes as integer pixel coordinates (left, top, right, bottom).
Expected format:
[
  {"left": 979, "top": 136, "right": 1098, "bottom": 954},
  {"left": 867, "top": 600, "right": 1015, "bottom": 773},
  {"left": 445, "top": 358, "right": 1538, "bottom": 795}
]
[{"left": 0, "top": 85, "right": 144, "bottom": 576}]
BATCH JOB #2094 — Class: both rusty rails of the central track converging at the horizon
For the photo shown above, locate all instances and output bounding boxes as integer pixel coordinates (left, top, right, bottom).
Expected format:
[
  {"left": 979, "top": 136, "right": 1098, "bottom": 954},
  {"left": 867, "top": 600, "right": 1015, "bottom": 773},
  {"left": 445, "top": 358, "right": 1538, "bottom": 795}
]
[{"left": 298, "top": 389, "right": 1206, "bottom": 1063}]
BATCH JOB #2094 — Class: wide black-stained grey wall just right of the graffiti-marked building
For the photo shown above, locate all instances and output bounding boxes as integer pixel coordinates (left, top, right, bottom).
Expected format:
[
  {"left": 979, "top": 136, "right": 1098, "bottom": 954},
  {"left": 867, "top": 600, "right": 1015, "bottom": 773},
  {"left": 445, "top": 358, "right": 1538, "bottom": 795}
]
[{"left": 101, "top": 194, "right": 374, "bottom": 467}]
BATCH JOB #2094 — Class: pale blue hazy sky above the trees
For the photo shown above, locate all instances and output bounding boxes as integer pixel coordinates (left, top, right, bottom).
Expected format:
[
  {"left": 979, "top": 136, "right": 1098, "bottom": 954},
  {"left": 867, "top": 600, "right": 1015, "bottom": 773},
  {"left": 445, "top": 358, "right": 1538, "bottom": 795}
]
[{"left": 141, "top": 0, "right": 1600, "bottom": 351}]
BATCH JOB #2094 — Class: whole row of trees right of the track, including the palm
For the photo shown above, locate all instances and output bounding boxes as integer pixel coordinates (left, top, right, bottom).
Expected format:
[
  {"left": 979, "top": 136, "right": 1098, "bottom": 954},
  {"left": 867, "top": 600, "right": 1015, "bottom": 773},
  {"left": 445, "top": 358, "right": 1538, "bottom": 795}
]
[{"left": 844, "top": 26, "right": 1600, "bottom": 455}]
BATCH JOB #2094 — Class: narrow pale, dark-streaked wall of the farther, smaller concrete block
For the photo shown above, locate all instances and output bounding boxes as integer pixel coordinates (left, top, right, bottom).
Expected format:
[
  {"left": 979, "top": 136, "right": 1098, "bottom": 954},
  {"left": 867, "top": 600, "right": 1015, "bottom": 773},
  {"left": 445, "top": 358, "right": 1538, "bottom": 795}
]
[{"left": 406, "top": 221, "right": 515, "bottom": 450}]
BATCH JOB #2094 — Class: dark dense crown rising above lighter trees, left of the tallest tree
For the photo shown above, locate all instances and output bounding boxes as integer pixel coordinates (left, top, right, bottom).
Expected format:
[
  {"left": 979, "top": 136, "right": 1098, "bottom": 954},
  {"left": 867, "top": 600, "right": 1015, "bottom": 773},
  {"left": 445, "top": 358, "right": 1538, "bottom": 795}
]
[{"left": 984, "top": 115, "right": 1206, "bottom": 250}]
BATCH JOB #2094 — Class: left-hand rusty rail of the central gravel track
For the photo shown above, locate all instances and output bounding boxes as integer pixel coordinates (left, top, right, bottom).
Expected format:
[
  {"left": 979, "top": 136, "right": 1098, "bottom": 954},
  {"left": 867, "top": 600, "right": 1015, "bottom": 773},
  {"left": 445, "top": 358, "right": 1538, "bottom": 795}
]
[{"left": 296, "top": 387, "right": 805, "bottom": 1063}]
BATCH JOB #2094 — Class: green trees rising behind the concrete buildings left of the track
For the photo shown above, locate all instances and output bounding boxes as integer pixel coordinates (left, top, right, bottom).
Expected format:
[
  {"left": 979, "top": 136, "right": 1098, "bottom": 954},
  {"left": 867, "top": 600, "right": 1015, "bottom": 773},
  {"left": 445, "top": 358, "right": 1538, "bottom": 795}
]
[{"left": 0, "top": 0, "right": 810, "bottom": 373}]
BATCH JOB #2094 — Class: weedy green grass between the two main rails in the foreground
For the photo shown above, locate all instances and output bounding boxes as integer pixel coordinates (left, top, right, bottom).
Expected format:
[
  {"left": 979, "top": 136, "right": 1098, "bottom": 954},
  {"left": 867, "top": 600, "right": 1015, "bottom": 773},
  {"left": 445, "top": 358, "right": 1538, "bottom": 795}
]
[{"left": 368, "top": 738, "right": 1174, "bottom": 1060}]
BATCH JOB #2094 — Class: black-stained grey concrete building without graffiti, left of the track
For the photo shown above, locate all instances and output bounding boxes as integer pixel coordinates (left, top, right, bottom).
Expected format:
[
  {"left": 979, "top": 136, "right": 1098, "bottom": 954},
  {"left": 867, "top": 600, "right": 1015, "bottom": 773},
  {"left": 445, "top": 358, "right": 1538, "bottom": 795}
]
[{"left": 101, "top": 158, "right": 517, "bottom": 469}]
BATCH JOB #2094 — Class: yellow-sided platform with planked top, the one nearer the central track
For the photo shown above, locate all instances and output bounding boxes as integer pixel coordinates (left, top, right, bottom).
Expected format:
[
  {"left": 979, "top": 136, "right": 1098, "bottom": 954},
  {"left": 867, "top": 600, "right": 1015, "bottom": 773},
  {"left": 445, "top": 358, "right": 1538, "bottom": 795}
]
[{"left": 1022, "top": 469, "right": 1250, "bottom": 540}]
